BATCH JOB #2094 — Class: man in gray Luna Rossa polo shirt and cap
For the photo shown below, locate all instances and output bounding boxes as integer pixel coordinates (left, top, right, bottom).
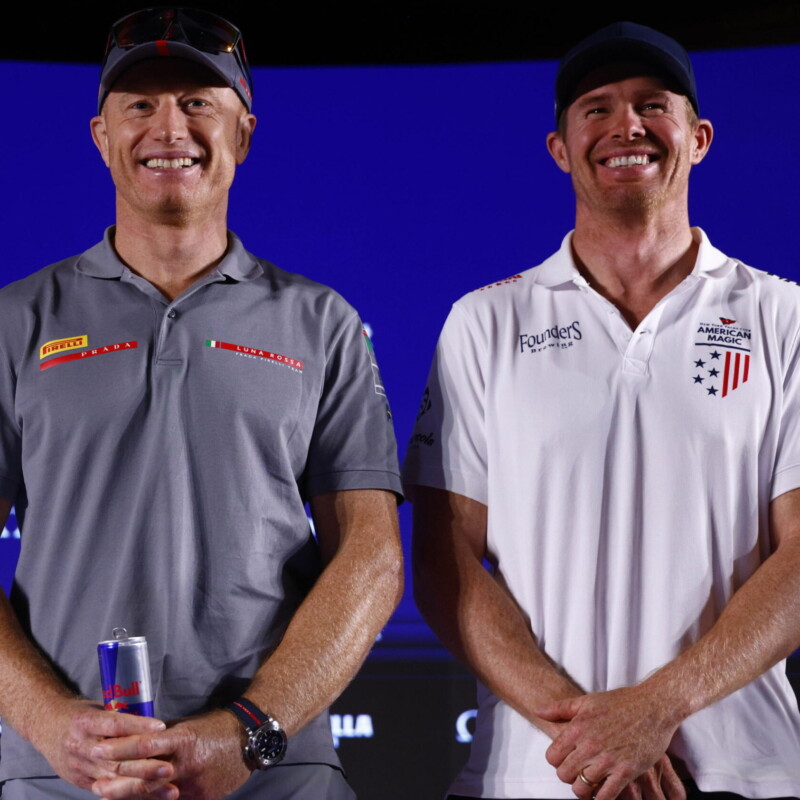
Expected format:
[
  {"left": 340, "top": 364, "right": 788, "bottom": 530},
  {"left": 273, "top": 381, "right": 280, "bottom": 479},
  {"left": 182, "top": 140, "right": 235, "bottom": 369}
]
[{"left": 0, "top": 10, "right": 401, "bottom": 800}]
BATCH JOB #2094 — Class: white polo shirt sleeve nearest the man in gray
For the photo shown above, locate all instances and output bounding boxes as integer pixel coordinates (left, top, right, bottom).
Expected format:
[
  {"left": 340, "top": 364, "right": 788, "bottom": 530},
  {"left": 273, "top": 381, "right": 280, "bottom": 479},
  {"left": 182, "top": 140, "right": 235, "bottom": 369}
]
[{"left": 403, "top": 304, "right": 488, "bottom": 504}]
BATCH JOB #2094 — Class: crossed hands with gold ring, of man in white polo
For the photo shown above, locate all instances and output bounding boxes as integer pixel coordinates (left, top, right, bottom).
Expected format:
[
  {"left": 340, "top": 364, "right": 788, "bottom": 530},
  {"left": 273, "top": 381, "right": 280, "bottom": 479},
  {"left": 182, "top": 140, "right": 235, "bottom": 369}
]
[{"left": 536, "top": 686, "right": 682, "bottom": 800}]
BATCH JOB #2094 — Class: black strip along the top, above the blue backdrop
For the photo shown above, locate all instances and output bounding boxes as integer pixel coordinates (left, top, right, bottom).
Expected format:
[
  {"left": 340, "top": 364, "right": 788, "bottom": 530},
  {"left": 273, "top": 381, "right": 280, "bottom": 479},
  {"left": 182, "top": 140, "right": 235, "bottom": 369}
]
[{"left": 3, "top": 0, "right": 800, "bottom": 66}]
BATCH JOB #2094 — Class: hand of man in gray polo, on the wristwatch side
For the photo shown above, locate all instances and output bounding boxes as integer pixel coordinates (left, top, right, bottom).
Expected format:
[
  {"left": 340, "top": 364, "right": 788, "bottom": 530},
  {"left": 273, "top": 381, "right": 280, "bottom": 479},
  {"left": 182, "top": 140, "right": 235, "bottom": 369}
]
[{"left": 91, "top": 711, "right": 250, "bottom": 800}]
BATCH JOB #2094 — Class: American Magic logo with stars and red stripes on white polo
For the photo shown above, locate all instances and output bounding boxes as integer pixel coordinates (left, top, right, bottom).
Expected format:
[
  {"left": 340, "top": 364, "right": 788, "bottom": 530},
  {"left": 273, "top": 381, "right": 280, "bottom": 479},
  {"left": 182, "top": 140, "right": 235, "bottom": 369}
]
[{"left": 692, "top": 317, "right": 752, "bottom": 397}]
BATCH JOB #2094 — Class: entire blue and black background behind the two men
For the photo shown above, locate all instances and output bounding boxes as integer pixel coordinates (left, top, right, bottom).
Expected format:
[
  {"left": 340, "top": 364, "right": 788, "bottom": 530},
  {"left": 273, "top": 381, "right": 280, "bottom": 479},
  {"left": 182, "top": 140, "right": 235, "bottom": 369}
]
[{"left": 0, "top": 2, "right": 800, "bottom": 800}]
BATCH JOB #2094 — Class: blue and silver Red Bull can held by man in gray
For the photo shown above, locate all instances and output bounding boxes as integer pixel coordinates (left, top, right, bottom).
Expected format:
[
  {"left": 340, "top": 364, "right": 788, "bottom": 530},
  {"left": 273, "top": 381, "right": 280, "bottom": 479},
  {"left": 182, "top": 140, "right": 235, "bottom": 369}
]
[{"left": 97, "top": 628, "right": 155, "bottom": 717}]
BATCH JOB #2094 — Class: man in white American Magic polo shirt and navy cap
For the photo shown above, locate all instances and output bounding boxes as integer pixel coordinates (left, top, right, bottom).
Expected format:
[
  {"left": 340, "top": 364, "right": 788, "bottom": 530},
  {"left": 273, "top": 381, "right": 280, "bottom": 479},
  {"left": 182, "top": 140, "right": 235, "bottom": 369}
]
[{"left": 404, "top": 18, "right": 800, "bottom": 800}]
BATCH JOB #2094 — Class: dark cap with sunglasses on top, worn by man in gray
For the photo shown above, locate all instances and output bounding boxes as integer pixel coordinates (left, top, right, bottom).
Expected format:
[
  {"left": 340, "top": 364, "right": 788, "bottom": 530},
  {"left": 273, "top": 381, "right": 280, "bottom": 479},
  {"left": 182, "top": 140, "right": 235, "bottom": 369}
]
[{"left": 97, "top": 7, "right": 253, "bottom": 114}]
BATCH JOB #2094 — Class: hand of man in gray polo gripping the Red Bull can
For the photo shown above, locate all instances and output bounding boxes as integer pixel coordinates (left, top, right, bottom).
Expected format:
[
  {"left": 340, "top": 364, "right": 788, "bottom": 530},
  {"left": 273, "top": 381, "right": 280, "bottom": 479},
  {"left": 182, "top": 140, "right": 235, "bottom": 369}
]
[{"left": 25, "top": 697, "right": 174, "bottom": 797}]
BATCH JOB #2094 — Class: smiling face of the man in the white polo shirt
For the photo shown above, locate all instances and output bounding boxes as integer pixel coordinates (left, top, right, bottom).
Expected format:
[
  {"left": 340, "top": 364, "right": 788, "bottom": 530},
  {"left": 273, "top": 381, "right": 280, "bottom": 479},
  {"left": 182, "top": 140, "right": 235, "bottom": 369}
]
[{"left": 547, "top": 64, "right": 712, "bottom": 219}]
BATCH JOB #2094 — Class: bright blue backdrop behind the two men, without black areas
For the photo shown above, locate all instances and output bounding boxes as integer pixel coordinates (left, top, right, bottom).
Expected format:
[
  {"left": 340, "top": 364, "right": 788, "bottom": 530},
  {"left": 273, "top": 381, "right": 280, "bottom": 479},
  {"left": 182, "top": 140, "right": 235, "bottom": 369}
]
[{"left": 0, "top": 47, "right": 800, "bottom": 658}]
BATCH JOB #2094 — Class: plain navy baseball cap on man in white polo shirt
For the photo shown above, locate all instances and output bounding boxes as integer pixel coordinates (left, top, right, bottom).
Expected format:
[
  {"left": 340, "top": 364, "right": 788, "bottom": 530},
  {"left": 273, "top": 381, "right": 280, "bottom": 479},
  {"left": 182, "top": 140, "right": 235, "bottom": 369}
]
[{"left": 556, "top": 22, "right": 700, "bottom": 124}]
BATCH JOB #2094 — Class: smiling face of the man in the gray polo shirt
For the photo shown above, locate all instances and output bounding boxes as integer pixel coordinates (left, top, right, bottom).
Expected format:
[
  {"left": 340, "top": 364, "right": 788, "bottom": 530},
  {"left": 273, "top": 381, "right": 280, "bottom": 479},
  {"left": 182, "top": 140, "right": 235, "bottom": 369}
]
[{"left": 91, "top": 58, "right": 255, "bottom": 225}]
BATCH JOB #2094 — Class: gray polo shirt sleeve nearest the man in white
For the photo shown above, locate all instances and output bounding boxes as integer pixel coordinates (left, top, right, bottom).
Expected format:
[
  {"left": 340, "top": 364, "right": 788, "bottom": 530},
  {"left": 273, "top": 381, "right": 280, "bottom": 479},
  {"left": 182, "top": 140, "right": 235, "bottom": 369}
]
[{"left": 304, "top": 314, "right": 402, "bottom": 498}]
